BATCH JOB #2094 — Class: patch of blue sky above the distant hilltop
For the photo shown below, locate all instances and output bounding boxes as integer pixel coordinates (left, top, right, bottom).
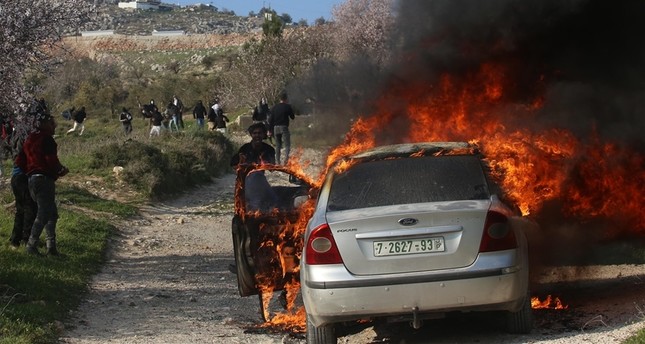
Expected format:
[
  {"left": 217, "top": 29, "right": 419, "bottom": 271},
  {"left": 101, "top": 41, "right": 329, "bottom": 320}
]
[{"left": 167, "top": 0, "right": 345, "bottom": 24}]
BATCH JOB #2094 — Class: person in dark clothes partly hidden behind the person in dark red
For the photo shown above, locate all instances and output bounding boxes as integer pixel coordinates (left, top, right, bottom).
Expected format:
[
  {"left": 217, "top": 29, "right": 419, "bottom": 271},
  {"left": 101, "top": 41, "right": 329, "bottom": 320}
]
[{"left": 9, "top": 119, "right": 38, "bottom": 248}]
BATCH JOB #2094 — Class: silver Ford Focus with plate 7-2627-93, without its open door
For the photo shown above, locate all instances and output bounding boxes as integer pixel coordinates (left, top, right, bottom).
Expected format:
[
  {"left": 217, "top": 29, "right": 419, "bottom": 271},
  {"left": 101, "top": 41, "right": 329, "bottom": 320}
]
[{"left": 300, "top": 142, "right": 535, "bottom": 343}]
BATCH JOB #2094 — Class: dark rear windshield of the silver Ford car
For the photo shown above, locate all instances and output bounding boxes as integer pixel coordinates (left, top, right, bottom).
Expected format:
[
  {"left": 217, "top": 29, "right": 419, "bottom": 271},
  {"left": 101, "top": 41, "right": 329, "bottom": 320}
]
[{"left": 327, "top": 155, "right": 490, "bottom": 211}]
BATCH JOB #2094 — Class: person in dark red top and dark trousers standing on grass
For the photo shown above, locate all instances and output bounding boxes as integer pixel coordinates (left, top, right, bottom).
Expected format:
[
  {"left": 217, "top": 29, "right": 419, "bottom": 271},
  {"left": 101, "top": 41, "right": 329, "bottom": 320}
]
[{"left": 17, "top": 113, "right": 69, "bottom": 256}]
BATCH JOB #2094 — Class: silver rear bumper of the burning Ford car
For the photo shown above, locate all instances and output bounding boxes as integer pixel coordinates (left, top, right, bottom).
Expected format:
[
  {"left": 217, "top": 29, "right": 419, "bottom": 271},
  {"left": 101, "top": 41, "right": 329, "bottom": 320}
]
[{"left": 301, "top": 251, "right": 528, "bottom": 326}]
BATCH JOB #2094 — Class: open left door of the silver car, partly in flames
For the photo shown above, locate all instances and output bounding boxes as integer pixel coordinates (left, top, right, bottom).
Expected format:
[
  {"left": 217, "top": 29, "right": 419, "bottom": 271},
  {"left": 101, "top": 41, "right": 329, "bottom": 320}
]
[{"left": 232, "top": 165, "right": 312, "bottom": 296}]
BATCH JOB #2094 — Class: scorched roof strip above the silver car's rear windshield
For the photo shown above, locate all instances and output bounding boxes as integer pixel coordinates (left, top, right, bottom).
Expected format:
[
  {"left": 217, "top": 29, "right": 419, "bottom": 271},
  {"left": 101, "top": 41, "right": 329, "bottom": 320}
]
[{"left": 348, "top": 142, "right": 479, "bottom": 160}]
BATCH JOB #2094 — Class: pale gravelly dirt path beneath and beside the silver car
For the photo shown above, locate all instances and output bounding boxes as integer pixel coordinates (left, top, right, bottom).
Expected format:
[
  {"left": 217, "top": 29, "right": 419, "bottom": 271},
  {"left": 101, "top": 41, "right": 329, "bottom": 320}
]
[{"left": 61, "top": 174, "right": 645, "bottom": 344}]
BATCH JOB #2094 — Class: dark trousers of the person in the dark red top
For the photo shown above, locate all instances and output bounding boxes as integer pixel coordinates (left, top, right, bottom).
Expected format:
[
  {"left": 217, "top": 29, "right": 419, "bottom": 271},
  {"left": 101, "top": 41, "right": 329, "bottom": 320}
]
[{"left": 27, "top": 174, "right": 58, "bottom": 247}]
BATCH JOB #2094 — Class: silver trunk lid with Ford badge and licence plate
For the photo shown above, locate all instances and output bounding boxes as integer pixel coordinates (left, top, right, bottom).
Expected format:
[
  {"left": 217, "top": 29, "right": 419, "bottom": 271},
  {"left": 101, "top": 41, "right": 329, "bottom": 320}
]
[{"left": 327, "top": 200, "right": 491, "bottom": 275}]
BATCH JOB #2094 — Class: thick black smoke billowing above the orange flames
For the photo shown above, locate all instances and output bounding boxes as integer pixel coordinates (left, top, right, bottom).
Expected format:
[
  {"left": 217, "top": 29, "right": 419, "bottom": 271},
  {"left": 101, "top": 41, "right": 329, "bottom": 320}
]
[{"left": 293, "top": 0, "right": 645, "bottom": 150}]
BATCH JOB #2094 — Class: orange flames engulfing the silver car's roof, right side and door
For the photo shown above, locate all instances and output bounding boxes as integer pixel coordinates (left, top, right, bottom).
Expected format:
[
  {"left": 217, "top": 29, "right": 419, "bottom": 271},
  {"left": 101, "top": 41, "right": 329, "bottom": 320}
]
[{"left": 245, "top": 64, "right": 645, "bottom": 331}]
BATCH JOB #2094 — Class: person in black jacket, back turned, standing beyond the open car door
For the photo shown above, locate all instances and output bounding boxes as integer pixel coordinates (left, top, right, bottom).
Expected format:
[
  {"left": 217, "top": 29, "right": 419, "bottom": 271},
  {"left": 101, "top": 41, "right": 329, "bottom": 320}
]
[{"left": 269, "top": 93, "right": 295, "bottom": 165}]
